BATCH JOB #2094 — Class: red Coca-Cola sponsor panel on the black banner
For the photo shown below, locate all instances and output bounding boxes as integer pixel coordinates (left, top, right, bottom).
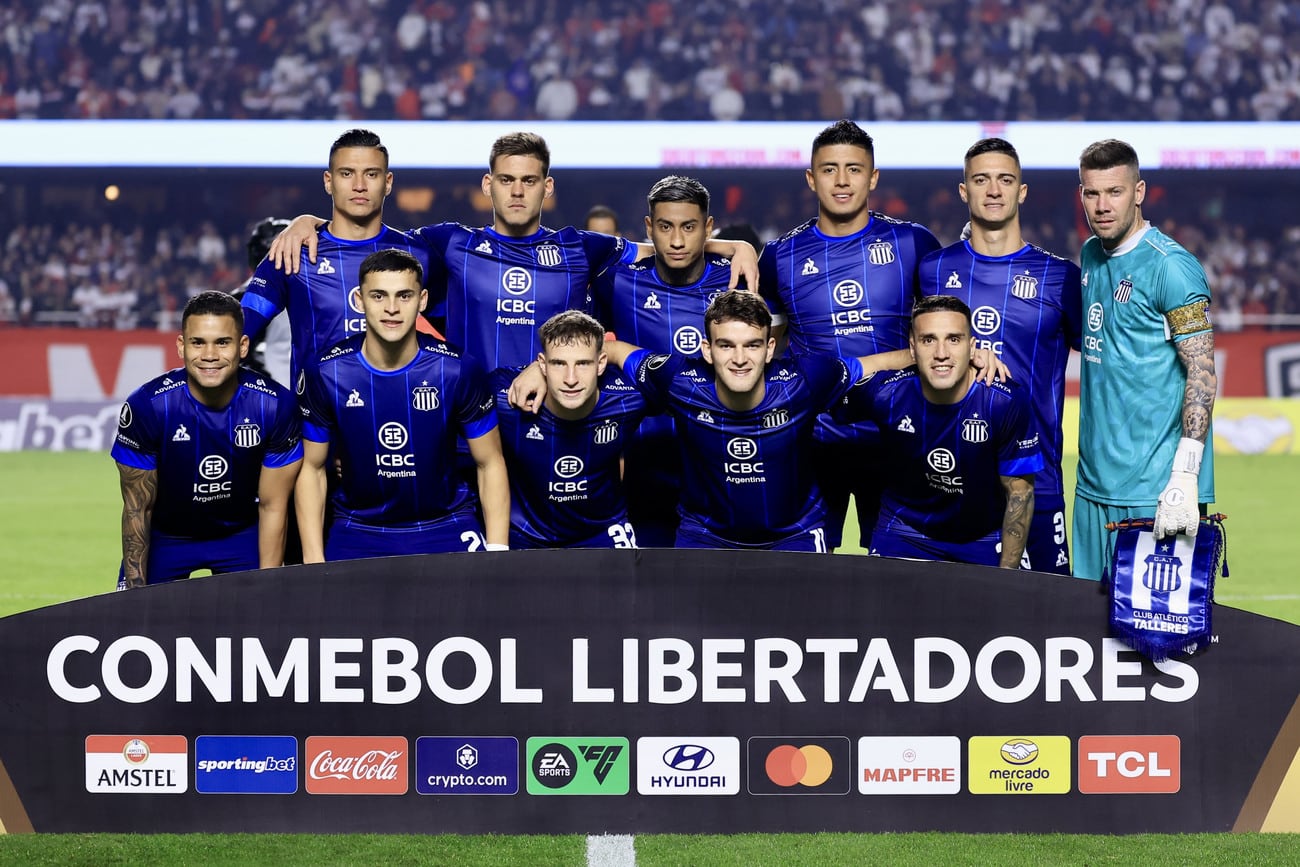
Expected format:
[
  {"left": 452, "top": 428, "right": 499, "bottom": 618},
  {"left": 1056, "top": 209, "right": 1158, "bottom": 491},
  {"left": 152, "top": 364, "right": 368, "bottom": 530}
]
[{"left": 304, "top": 737, "right": 410, "bottom": 794}]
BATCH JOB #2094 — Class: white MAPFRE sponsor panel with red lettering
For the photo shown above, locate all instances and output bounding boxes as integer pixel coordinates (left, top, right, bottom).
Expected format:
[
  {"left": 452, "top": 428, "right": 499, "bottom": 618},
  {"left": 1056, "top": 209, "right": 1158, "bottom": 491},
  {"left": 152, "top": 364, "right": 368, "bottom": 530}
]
[{"left": 858, "top": 737, "right": 962, "bottom": 794}]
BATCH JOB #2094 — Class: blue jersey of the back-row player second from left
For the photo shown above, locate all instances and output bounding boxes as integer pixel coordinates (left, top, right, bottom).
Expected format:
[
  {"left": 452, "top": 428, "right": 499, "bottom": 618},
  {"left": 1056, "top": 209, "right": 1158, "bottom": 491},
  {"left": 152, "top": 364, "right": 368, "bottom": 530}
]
[{"left": 412, "top": 222, "right": 637, "bottom": 370}]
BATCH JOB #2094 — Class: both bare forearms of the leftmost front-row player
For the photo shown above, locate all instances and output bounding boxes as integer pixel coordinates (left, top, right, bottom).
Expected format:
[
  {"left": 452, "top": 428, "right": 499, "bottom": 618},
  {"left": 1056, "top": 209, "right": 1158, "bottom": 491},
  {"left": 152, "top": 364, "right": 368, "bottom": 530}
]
[{"left": 117, "top": 460, "right": 300, "bottom": 588}]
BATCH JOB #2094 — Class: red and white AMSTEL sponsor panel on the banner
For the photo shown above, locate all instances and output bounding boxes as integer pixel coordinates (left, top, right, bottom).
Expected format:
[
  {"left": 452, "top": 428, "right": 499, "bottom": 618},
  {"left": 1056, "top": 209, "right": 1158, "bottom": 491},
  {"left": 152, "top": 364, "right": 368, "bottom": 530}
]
[{"left": 86, "top": 734, "right": 190, "bottom": 794}]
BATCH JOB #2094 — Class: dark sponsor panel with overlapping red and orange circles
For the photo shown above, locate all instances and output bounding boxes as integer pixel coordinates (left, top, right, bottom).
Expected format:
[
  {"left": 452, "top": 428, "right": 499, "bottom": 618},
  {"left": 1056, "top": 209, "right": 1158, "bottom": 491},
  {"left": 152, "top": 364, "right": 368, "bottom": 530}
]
[{"left": 745, "top": 737, "right": 853, "bottom": 794}]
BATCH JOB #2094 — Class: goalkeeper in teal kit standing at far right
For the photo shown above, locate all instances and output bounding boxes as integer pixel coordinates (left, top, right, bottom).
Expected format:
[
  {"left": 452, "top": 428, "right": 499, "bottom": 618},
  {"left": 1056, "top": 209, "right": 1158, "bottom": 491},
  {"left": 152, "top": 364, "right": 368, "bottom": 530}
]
[{"left": 1074, "top": 139, "right": 1218, "bottom": 580}]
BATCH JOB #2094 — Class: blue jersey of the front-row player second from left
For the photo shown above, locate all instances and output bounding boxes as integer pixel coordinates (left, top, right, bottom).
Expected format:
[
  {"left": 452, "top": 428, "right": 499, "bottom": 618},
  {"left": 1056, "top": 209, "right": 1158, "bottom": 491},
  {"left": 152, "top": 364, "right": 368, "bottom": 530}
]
[{"left": 299, "top": 334, "right": 497, "bottom": 528}]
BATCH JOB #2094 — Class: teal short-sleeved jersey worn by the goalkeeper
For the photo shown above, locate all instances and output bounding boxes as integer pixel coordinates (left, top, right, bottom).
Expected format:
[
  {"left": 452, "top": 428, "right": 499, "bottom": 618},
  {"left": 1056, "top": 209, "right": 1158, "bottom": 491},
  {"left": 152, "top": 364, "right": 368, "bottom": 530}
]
[{"left": 1078, "top": 225, "right": 1214, "bottom": 504}]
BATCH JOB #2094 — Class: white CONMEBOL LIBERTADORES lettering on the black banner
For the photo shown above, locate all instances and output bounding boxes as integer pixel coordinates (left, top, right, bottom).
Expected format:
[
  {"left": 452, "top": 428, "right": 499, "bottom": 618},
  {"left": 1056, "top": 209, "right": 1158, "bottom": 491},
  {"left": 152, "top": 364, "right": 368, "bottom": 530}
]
[{"left": 46, "top": 634, "right": 1200, "bottom": 705}]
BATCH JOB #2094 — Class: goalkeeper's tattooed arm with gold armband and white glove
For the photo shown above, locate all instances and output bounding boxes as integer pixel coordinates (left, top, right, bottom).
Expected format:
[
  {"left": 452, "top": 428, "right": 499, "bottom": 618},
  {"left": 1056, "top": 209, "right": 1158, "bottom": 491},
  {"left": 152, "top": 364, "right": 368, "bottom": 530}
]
[{"left": 1153, "top": 300, "right": 1218, "bottom": 538}]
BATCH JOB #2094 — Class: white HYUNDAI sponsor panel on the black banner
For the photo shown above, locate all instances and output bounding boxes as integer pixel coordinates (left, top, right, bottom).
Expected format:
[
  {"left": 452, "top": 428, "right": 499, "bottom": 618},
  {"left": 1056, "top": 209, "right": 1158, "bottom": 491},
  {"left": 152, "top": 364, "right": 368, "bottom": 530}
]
[{"left": 637, "top": 737, "right": 740, "bottom": 794}]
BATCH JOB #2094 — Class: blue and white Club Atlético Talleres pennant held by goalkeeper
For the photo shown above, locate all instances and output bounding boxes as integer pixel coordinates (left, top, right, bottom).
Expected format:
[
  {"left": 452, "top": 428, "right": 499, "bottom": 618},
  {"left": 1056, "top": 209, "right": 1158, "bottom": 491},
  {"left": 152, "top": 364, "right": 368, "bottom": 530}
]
[{"left": 1109, "top": 515, "right": 1226, "bottom": 662}]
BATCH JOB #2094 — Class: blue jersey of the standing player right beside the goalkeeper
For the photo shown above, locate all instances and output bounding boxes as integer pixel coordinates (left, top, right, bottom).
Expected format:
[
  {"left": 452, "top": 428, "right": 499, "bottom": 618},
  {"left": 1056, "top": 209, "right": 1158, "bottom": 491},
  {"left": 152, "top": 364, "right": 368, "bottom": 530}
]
[{"left": 920, "top": 240, "right": 1083, "bottom": 511}]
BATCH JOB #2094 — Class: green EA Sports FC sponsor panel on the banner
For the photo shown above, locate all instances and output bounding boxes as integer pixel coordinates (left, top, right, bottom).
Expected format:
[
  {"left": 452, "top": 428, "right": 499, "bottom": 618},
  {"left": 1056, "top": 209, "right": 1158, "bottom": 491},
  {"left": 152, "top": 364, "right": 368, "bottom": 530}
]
[{"left": 527, "top": 737, "right": 631, "bottom": 794}]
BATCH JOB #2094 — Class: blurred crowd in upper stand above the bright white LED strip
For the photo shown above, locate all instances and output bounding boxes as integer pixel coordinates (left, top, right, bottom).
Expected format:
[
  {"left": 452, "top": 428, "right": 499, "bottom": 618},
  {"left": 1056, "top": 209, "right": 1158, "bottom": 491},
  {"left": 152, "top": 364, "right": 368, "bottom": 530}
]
[{"left": 0, "top": 0, "right": 1300, "bottom": 121}]
